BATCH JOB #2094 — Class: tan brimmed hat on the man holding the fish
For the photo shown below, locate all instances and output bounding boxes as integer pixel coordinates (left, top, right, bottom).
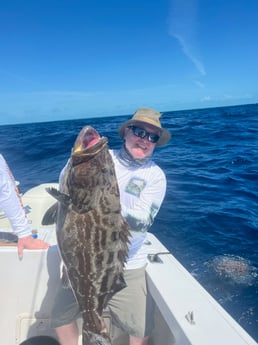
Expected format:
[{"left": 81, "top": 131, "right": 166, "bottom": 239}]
[{"left": 118, "top": 108, "right": 171, "bottom": 146}]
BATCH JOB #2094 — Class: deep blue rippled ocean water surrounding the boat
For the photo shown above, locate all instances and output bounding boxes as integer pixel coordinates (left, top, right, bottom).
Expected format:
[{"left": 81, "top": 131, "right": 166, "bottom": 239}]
[{"left": 0, "top": 104, "right": 258, "bottom": 341}]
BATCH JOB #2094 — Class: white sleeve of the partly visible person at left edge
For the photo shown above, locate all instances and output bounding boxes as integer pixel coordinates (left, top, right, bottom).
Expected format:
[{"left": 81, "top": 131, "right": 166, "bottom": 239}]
[{"left": 0, "top": 154, "right": 32, "bottom": 238}]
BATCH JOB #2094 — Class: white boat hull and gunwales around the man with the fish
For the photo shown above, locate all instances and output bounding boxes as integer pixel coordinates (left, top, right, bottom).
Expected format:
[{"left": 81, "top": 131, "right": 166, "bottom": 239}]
[{"left": 0, "top": 184, "right": 257, "bottom": 345}]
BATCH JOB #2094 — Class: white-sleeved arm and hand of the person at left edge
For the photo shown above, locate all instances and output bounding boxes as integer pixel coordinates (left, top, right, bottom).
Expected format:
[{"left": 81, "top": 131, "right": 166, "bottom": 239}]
[{"left": 0, "top": 155, "right": 49, "bottom": 258}]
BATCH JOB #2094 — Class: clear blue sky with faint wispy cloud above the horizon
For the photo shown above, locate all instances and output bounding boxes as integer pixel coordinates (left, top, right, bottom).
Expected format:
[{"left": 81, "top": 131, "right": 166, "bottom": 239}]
[{"left": 0, "top": 0, "right": 258, "bottom": 124}]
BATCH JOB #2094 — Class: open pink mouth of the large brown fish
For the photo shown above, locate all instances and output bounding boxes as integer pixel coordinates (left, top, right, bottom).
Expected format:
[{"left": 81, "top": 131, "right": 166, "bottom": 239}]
[{"left": 72, "top": 126, "right": 107, "bottom": 154}]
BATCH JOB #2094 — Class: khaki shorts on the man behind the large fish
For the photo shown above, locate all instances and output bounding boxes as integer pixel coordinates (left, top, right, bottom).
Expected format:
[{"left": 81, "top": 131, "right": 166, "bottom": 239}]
[{"left": 51, "top": 267, "right": 154, "bottom": 338}]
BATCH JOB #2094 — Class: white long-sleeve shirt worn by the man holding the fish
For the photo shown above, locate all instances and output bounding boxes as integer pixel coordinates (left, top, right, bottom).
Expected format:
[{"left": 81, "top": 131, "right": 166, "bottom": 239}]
[{"left": 110, "top": 150, "right": 167, "bottom": 269}]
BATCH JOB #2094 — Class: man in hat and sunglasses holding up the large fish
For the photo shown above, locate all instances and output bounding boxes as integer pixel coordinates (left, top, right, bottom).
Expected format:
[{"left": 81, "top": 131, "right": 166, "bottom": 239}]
[{"left": 52, "top": 108, "right": 171, "bottom": 345}]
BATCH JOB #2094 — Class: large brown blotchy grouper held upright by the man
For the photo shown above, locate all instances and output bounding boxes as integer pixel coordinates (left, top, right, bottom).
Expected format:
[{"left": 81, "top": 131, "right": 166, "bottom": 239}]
[{"left": 42, "top": 126, "right": 130, "bottom": 345}]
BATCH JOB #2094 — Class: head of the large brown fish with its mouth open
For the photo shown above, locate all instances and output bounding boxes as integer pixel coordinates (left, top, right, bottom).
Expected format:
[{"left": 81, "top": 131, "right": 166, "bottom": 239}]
[{"left": 62, "top": 126, "right": 118, "bottom": 210}]
